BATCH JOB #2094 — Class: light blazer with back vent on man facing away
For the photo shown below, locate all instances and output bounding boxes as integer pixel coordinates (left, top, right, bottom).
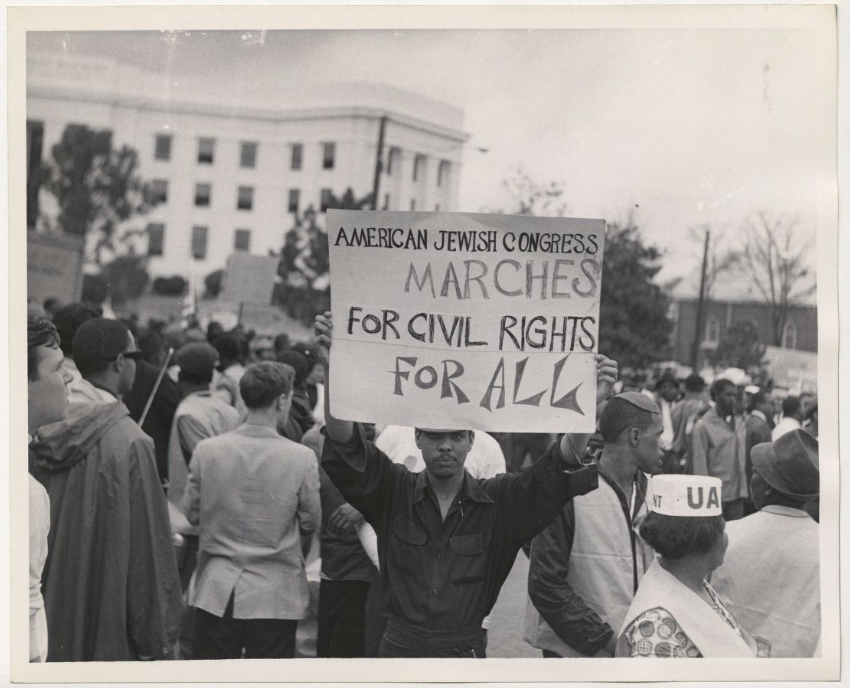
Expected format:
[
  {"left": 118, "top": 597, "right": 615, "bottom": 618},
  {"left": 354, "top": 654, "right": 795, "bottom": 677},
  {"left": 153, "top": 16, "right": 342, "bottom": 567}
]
[{"left": 184, "top": 423, "right": 322, "bottom": 619}]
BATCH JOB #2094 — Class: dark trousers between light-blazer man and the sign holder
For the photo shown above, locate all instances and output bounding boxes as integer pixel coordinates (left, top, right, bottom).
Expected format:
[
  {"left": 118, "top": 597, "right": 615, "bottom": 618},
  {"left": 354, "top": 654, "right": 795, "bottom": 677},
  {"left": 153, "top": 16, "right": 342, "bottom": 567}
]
[{"left": 316, "top": 580, "right": 370, "bottom": 657}]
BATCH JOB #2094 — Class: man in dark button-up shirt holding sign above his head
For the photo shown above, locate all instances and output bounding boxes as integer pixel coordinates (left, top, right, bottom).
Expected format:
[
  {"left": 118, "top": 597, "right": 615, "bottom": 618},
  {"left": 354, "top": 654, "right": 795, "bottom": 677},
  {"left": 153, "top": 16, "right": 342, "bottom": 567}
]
[{"left": 315, "top": 313, "right": 617, "bottom": 657}]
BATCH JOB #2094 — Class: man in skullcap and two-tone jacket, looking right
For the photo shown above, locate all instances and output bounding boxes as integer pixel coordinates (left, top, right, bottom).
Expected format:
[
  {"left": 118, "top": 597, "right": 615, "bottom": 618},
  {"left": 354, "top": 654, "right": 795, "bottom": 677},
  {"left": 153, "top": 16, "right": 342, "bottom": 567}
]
[{"left": 525, "top": 392, "right": 663, "bottom": 657}]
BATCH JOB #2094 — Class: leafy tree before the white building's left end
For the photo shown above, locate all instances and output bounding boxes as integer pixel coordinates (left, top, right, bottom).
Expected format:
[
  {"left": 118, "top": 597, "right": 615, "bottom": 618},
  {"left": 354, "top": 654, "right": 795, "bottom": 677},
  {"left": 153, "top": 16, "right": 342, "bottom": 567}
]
[{"left": 41, "top": 124, "right": 154, "bottom": 266}]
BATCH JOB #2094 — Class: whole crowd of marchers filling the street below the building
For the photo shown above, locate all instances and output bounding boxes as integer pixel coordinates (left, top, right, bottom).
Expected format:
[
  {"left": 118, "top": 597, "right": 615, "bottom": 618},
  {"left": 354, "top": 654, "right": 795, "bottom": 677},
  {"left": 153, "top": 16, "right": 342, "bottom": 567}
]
[{"left": 28, "top": 303, "right": 821, "bottom": 662}]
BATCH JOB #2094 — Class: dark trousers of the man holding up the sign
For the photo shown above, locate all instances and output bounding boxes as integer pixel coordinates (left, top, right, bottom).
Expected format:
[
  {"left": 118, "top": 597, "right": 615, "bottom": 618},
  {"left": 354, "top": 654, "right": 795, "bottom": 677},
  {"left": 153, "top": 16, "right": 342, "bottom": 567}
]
[{"left": 379, "top": 616, "right": 487, "bottom": 659}]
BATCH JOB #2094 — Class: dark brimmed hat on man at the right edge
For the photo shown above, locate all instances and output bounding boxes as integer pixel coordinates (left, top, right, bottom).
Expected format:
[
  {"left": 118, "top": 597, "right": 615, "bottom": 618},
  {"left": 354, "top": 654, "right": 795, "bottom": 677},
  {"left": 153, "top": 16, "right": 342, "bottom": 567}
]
[{"left": 751, "top": 430, "right": 820, "bottom": 502}]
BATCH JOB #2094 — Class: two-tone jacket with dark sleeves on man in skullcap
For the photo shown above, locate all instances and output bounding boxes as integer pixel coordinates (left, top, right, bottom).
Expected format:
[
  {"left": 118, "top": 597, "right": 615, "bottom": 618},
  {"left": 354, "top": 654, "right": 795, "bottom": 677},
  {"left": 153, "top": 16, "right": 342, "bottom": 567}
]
[{"left": 525, "top": 466, "right": 654, "bottom": 657}]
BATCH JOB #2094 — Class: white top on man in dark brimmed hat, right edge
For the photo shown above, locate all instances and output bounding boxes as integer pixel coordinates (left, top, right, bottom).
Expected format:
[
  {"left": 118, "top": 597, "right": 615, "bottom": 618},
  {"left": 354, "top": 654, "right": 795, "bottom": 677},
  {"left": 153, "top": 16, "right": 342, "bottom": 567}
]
[{"left": 711, "top": 505, "right": 821, "bottom": 657}]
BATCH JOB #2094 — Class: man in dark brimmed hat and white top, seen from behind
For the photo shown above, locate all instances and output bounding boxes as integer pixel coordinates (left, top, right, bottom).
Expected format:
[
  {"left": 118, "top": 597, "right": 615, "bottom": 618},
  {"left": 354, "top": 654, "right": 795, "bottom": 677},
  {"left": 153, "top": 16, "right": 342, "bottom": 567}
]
[{"left": 712, "top": 430, "right": 821, "bottom": 657}]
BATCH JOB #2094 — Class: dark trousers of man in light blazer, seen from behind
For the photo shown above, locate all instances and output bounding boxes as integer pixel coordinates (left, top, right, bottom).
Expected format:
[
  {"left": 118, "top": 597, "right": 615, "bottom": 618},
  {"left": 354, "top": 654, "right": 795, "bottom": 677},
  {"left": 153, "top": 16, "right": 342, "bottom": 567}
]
[{"left": 193, "top": 595, "right": 298, "bottom": 659}]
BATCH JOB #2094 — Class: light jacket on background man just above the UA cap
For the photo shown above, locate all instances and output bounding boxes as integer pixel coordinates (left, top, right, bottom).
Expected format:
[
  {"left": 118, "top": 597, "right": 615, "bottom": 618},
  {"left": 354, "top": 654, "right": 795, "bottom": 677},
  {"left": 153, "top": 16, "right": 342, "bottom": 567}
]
[{"left": 692, "top": 408, "right": 750, "bottom": 502}]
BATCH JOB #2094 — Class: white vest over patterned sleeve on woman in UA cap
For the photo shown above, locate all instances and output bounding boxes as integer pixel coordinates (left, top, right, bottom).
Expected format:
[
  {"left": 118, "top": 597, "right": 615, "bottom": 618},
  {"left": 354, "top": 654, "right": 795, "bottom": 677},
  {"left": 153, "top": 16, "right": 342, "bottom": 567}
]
[{"left": 616, "top": 560, "right": 758, "bottom": 659}]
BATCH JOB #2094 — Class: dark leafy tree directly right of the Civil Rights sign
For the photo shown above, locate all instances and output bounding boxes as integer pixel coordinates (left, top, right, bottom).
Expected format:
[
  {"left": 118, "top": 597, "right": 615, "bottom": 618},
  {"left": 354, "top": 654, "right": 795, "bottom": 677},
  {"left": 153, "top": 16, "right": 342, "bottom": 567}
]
[{"left": 599, "top": 216, "right": 672, "bottom": 368}]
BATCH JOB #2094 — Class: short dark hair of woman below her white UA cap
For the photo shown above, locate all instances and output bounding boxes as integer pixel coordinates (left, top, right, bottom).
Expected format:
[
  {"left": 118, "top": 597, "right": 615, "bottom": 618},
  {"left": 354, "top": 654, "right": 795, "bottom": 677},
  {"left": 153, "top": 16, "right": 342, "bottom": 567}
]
[{"left": 640, "top": 511, "right": 725, "bottom": 561}]
